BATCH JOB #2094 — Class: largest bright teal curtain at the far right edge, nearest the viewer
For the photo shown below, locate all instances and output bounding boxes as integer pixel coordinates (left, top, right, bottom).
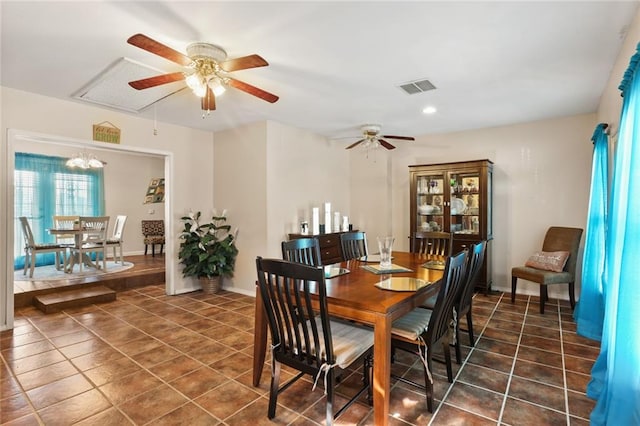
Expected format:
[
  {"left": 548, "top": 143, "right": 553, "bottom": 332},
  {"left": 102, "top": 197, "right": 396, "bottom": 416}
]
[{"left": 587, "top": 45, "right": 640, "bottom": 425}]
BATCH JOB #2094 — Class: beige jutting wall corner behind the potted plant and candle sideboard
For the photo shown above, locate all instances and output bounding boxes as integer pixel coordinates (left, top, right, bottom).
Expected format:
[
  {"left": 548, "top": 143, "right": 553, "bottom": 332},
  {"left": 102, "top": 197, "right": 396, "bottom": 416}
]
[{"left": 214, "top": 121, "right": 350, "bottom": 295}]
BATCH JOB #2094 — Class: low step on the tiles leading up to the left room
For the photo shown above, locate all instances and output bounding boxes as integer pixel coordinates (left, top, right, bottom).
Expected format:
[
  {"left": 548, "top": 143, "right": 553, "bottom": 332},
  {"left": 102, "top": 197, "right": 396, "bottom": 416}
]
[{"left": 33, "top": 286, "right": 116, "bottom": 314}]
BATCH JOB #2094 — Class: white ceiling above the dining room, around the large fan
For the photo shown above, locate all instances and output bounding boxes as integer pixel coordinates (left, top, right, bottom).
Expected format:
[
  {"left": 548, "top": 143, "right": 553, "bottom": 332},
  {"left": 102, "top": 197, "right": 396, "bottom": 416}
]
[{"left": 0, "top": 1, "right": 638, "bottom": 143}]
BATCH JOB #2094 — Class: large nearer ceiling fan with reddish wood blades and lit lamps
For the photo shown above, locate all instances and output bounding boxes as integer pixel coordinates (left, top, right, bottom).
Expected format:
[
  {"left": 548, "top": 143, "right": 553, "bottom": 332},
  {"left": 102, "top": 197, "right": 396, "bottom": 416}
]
[{"left": 127, "top": 34, "right": 279, "bottom": 112}]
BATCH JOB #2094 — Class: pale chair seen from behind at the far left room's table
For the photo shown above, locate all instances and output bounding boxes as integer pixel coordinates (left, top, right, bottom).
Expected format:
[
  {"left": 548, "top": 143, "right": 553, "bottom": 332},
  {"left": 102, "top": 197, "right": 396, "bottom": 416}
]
[{"left": 71, "top": 216, "right": 109, "bottom": 272}]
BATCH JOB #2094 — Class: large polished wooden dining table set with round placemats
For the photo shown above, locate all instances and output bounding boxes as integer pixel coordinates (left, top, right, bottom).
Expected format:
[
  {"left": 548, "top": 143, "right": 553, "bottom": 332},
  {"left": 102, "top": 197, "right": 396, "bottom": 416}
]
[{"left": 253, "top": 252, "right": 444, "bottom": 425}]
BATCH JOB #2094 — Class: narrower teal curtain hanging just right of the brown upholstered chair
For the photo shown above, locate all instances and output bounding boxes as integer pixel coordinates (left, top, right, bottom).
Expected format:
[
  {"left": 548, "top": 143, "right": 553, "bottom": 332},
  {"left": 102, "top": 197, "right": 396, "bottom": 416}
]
[{"left": 573, "top": 123, "right": 609, "bottom": 341}]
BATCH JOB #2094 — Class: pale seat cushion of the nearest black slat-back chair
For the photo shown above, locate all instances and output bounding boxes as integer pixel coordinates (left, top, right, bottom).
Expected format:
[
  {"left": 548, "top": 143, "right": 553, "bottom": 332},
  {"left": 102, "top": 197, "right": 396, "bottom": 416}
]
[{"left": 306, "top": 316, "right": 373, "bottom": 369}]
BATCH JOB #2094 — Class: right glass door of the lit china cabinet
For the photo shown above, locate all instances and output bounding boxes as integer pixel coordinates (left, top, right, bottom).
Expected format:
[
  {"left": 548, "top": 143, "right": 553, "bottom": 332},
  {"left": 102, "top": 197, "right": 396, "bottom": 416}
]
[{"left": 449, "top": 170, "right": 482, "bottom": 236}]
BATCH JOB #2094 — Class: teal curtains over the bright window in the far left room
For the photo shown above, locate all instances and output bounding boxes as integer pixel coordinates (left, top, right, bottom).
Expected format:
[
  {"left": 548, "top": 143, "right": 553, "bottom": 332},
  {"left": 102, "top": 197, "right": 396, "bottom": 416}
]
[{"left": 13, "top": 152, "right": 104, "bottom": 269}]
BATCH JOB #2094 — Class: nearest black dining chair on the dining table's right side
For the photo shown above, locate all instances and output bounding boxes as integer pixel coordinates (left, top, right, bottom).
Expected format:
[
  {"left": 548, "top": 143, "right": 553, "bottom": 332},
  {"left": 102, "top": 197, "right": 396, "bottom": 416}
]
[{"left": 391, "top": 251, "right": 467, "bottom": 413}]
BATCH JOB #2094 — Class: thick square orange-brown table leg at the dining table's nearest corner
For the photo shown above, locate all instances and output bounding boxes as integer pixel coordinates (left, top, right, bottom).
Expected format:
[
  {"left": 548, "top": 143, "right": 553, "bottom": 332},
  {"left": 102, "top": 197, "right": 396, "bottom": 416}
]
[{"left": 373, "top": 315, "right": 391, "bottom": 426}]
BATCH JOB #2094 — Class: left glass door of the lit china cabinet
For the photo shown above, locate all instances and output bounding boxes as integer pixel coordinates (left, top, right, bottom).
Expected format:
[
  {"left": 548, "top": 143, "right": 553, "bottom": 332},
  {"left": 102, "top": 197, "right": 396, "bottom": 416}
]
[{"left": 416, "top": 173, "right": 449, "bottom": 231}]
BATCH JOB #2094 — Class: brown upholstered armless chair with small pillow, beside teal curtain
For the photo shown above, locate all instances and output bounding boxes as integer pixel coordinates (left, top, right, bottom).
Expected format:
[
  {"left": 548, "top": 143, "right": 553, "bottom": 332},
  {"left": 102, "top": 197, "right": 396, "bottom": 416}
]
[{"left": 511, "top": 226, "right": 582, "bottom": 314}]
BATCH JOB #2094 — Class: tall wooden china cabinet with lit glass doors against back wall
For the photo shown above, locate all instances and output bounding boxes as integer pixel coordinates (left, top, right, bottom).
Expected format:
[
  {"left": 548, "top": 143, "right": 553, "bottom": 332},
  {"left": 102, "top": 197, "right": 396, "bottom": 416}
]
[{"left": 409, "top": 160, "right": 493, "bottom": 293}]
